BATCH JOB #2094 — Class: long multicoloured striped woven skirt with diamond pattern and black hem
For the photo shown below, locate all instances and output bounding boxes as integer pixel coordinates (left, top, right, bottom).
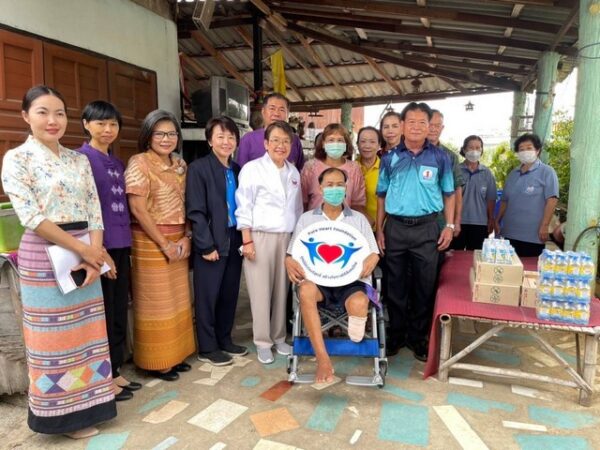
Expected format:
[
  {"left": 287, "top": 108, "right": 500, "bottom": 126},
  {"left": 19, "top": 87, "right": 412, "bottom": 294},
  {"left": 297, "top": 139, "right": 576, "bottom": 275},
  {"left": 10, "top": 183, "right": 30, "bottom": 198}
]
[{"left": 18, "top": 230, "right": 117, "bottom": 434}]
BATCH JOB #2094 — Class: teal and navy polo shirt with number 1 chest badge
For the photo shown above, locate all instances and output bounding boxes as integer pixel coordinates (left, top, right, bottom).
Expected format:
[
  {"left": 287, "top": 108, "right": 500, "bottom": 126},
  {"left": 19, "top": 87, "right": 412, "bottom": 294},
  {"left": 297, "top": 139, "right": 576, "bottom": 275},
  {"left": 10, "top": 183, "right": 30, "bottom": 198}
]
[{"left": 377, "top": 140, "right": 454, "bottom": 217}]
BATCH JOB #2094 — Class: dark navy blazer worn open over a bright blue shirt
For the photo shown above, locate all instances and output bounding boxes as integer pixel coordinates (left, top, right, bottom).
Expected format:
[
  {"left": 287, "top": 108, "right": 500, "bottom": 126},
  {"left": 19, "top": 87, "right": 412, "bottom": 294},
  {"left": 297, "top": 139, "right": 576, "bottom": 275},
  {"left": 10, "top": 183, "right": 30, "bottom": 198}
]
[{"left": 185, "top": 152, "right": 240, "bottom": 256}]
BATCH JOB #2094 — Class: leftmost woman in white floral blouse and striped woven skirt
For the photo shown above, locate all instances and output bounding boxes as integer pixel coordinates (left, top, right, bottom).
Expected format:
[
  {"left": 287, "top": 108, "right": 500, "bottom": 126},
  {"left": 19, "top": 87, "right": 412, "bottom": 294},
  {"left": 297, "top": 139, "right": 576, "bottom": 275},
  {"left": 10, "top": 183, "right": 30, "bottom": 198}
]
[{"left": 2, "top": 86, "right": 117, "bottom": 438}]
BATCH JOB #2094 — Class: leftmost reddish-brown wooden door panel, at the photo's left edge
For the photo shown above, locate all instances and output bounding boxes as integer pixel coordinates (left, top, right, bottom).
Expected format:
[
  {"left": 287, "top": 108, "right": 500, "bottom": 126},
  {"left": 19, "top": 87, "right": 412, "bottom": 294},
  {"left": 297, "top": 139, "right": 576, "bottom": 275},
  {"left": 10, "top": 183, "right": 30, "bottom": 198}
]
[{"left": 0, "top": 30, "right": 44, "bottom": 202}]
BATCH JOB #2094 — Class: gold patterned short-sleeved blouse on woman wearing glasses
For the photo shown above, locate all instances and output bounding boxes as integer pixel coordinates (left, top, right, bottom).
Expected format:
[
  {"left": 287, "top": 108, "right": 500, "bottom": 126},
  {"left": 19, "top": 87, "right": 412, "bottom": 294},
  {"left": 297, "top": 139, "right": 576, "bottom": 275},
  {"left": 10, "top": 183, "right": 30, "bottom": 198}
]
[{"left": 125, "top": 150, "right": 187, "bottom": 225}]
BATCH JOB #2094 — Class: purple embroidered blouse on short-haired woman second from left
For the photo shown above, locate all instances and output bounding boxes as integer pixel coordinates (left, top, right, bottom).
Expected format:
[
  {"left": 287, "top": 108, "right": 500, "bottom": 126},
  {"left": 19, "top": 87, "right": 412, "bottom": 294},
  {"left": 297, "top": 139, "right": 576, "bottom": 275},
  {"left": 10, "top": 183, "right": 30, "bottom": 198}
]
[{"left": 78, "top": 142, "right": 131, "bottom": 248}]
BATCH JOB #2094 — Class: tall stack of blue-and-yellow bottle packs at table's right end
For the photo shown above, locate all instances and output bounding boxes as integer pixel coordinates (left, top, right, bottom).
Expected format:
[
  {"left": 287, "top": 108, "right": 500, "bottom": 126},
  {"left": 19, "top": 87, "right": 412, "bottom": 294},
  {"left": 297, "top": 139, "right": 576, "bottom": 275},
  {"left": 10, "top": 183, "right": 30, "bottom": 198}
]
[{"left": 536, "top": 250, "right": 594, "bottom": 325}]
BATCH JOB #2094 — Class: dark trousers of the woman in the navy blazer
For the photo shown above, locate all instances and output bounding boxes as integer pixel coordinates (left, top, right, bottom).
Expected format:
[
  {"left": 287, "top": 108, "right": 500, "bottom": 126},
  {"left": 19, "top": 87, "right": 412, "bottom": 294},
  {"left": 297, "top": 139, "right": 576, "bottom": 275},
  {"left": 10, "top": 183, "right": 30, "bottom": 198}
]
[{"left": 194, "top": 228, "right": 242, "bottom": 353}]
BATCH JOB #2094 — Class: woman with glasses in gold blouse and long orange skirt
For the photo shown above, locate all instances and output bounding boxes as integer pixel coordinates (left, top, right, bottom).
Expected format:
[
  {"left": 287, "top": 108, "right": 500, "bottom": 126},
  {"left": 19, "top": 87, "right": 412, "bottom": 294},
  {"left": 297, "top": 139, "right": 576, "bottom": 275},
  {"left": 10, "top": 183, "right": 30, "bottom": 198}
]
[{"left": 125, "top": 110, "right": 196, "bottom": 381}]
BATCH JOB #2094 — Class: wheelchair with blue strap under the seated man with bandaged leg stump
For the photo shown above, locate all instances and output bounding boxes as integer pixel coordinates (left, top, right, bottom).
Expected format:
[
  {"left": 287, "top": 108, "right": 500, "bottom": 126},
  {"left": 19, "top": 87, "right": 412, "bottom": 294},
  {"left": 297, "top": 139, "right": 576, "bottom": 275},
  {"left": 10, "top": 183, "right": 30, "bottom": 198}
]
[{"left": 287, "top": 267, "right": 388, "bottom": 388}]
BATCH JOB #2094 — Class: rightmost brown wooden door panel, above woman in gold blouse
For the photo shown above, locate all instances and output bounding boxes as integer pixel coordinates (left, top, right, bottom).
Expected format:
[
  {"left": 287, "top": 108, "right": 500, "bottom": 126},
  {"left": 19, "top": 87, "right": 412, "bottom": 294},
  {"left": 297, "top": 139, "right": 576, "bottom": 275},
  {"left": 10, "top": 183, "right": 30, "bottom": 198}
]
[{"left": 108, "top": 61, "right": 157, "bottom": 164}]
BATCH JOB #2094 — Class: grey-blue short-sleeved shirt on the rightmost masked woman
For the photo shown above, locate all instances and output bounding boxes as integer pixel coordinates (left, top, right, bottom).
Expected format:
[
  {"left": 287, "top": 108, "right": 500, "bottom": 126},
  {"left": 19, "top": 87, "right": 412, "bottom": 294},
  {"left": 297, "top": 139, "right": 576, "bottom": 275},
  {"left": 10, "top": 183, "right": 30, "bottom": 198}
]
[{"left": 500, "top": 160, "right": 558, "bottom": 244}]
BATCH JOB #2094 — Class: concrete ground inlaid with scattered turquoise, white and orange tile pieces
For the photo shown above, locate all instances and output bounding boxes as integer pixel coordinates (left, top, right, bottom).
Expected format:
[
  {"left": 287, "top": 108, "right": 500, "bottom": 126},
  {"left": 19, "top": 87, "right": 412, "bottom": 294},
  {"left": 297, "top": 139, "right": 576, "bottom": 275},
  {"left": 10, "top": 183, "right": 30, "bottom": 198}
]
[{"left": 0, "top": 280, "right": 600, "bottom": 450}]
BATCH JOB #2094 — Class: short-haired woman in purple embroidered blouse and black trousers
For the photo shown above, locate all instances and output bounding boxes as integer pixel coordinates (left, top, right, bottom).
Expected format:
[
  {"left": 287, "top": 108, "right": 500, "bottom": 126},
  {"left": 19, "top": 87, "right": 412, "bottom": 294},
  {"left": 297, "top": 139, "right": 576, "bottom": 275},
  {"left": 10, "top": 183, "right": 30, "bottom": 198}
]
[{"left": 79, "top": 100, "right": 142, "bottom": 401}]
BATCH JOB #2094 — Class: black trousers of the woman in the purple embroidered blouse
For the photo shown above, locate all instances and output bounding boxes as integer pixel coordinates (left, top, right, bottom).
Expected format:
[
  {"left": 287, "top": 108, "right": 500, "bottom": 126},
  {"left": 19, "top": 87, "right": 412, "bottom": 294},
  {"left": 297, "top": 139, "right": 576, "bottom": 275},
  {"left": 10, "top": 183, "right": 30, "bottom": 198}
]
[{"left": 100, "top": 247, "right": 131, "bottom": 378}]
